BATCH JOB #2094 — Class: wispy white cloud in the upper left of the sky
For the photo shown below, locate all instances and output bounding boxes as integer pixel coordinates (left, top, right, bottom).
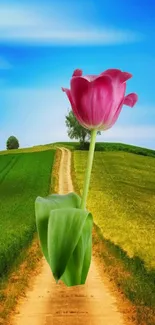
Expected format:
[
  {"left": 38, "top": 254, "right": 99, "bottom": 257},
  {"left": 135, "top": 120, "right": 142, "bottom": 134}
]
[{"left": 0, "top": 5, "right": 141, "bottom": 45}]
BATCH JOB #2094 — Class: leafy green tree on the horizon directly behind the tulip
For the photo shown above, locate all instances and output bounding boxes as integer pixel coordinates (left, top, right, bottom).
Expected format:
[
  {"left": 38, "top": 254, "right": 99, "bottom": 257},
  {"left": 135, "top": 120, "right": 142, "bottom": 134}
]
[{"left": 65, "top": 111, "right": 101, "bottom": 148}]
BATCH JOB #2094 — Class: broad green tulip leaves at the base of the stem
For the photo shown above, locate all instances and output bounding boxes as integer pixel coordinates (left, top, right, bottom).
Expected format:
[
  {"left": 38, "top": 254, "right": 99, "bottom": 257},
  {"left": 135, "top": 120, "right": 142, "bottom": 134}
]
[{"left": 35, "top": 193, "right": 93, "bottom": 286}]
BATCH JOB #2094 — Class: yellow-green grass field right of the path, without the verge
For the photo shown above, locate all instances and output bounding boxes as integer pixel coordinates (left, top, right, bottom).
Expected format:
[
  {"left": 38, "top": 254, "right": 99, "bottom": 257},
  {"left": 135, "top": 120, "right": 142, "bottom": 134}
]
[{"left": 74, "top": 151, "right": 155, "bottom": 269}]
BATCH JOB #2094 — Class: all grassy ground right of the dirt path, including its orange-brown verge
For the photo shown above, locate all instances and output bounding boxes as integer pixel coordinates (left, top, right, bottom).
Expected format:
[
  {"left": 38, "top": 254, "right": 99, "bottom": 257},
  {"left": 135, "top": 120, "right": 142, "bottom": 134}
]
[{"left": 72, "top": 151, "right": 155, "bottom": 325}]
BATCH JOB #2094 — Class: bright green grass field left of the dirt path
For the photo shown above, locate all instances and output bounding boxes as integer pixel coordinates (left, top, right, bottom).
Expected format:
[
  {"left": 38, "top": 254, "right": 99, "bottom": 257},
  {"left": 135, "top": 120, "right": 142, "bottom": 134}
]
[{"left": 0, "top": 150, "right": 55, "bottom": 275}]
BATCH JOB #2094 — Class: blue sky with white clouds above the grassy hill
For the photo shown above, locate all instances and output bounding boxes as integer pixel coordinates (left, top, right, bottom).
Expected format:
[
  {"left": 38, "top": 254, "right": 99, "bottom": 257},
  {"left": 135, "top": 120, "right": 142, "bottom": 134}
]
[{"left": 0, "top": 0, "right": 155, "bottom": 150}]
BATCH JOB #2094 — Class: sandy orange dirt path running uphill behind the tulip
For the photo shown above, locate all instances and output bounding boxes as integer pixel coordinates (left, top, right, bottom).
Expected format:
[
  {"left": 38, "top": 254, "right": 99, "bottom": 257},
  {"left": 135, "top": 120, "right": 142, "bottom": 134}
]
[{"left": 11, "top": 148, "right": 124, "bottom": 325}]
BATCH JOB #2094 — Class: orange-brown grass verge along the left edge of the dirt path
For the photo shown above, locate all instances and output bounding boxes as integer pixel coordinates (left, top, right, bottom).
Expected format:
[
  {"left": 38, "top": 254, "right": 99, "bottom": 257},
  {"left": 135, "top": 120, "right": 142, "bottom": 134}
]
[{"left": 0, "top": 150, "right": 61, "bottom": 325}]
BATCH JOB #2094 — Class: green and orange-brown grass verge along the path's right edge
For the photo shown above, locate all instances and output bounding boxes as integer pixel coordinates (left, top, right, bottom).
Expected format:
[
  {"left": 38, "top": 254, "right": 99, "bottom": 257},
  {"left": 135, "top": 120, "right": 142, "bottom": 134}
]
[{"left": 93, "top": 224, "right": 155, "bottom": 325}]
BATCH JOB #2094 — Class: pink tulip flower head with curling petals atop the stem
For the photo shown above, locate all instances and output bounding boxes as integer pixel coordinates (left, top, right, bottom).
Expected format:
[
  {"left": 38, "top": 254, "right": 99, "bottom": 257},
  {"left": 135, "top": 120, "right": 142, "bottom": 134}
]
[{"left": 62, "top": 69, "right": 138, "bottom": 130}]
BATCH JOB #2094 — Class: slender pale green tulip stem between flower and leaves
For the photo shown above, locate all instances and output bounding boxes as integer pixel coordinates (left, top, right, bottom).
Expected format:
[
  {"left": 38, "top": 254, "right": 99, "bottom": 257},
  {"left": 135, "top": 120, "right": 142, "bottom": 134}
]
[{"left": 81, "top": 130, "right": 97, "bottom": 210}]
